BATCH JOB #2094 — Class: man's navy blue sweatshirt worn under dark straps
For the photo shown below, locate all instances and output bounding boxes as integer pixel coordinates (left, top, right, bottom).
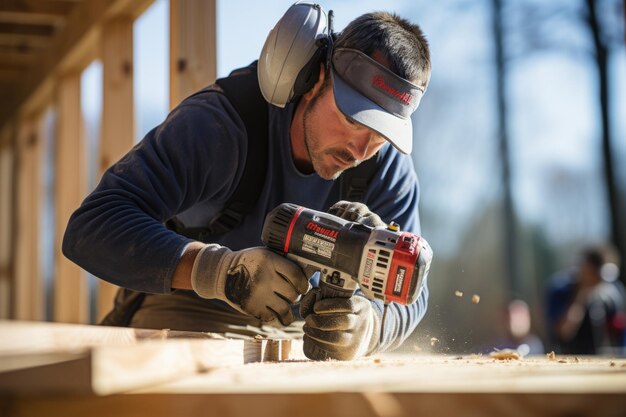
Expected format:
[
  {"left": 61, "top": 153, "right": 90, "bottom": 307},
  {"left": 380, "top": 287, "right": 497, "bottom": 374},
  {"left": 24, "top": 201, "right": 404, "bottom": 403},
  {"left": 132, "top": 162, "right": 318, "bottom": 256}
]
[{"left": 63, "top": 86, "right": 428, "bottom": 351}]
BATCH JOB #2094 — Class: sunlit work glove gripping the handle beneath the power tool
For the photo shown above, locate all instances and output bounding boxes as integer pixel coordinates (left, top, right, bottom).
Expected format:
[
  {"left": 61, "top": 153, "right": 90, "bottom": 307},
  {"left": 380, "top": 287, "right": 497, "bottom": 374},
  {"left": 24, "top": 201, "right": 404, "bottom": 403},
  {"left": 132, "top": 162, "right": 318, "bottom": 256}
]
[{"left": 300, "top": 288, "right": 381, "bottom": 361}]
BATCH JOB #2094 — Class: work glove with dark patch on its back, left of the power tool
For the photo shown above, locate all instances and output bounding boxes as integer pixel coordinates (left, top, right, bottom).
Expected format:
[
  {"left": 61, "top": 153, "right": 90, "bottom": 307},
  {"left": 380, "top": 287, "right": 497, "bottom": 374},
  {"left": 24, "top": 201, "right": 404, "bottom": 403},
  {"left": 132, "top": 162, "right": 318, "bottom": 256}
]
[{"left": 191, "top": 244, "right": 310, "bottom": 326}]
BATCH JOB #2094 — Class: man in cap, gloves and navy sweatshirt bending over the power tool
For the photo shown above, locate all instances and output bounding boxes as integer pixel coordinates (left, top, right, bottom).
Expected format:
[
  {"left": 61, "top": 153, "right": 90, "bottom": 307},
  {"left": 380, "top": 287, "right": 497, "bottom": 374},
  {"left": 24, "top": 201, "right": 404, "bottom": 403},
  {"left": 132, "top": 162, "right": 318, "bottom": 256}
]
[{"left": 63, "top": 5, "right": 430, "bottom": 360}]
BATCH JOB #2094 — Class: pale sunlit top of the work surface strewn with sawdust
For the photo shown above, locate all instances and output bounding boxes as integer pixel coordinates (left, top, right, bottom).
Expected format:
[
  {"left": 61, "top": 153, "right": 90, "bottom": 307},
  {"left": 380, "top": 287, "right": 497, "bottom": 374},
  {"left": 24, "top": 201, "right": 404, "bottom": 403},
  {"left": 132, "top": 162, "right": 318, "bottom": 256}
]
[{"left": 142, "top": 355, "right": 626, "bottom": 394}]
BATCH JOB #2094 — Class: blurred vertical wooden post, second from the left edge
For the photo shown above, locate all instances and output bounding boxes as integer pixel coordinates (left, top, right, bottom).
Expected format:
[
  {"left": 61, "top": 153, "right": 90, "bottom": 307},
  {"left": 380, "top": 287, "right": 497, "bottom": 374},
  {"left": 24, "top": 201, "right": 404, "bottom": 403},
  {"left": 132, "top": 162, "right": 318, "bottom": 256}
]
[{"left": 15, "top": 116, "right": 45, "bottom": 320}]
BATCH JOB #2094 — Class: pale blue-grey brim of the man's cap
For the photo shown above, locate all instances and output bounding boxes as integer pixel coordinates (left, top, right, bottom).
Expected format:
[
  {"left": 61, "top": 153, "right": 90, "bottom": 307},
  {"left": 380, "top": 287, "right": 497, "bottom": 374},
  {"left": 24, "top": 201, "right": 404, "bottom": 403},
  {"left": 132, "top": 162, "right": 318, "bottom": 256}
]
[{"left": 331, "top": 70, "right": 413, "bottom": 154}]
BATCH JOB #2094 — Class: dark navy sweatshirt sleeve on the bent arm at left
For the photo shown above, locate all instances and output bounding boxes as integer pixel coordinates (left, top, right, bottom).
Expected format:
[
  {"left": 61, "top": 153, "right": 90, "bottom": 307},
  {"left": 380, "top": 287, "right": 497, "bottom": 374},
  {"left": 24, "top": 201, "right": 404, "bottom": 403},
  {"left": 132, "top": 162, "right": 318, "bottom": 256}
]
[{"left": 62, "top": 93, "right": 247, "bottom": 293}]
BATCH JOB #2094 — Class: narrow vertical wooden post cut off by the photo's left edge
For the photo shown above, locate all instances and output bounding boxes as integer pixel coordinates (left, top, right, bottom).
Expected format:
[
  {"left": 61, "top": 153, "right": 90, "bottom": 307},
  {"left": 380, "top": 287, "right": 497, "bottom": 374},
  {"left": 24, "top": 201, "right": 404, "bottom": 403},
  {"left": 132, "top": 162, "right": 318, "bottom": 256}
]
[{"left": 0, "top": 126, "right": 16, "bottom": 319}]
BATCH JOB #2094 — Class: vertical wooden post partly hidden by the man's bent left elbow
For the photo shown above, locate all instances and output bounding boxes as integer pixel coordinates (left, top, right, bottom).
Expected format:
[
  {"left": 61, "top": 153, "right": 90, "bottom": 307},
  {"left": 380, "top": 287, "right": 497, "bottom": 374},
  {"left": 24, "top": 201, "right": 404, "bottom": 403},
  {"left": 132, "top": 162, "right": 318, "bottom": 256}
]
[{"left": 54, "top": 72, "right": 89, "bottom": 323}]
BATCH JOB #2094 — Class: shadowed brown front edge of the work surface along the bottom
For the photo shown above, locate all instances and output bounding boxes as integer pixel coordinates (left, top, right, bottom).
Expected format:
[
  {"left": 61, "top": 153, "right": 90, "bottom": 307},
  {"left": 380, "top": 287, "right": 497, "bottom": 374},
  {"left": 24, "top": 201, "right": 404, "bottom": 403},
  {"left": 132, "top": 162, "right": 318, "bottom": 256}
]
[{"left": 0, "top": 392, "right": 626, "bottom": 417}]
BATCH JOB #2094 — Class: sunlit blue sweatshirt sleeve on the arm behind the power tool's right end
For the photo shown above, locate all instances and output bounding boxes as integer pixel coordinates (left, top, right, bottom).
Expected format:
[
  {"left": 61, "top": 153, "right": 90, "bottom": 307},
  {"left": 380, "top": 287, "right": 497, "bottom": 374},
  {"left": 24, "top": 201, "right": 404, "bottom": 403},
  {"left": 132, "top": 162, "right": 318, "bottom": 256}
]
[{"left": 357, "top": 146, "right": 428, "bottom": 353}]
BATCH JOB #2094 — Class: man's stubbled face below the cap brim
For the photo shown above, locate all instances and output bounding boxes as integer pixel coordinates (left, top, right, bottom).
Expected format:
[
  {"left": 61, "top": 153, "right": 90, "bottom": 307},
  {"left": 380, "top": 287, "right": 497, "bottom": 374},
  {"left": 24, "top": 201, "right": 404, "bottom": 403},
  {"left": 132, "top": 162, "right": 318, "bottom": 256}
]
[{"left": 303, "top": 80, "right": 386, "bottom": 180}]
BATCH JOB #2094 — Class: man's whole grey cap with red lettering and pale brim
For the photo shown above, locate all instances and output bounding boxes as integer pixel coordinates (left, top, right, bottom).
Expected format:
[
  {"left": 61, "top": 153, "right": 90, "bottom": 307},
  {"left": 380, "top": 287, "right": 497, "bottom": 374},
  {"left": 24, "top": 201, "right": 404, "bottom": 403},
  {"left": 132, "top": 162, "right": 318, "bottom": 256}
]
[{"left": 331, "top": 48, "right": 424, "bottom": 154}]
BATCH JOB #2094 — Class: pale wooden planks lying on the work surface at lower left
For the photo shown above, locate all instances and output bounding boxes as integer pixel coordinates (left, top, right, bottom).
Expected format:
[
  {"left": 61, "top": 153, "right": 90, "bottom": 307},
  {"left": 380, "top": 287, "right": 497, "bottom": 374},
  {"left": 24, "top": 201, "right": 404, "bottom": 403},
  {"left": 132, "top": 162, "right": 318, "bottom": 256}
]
[{"left": 0, "top": 321, "right": 301, "bottom": 394}]
